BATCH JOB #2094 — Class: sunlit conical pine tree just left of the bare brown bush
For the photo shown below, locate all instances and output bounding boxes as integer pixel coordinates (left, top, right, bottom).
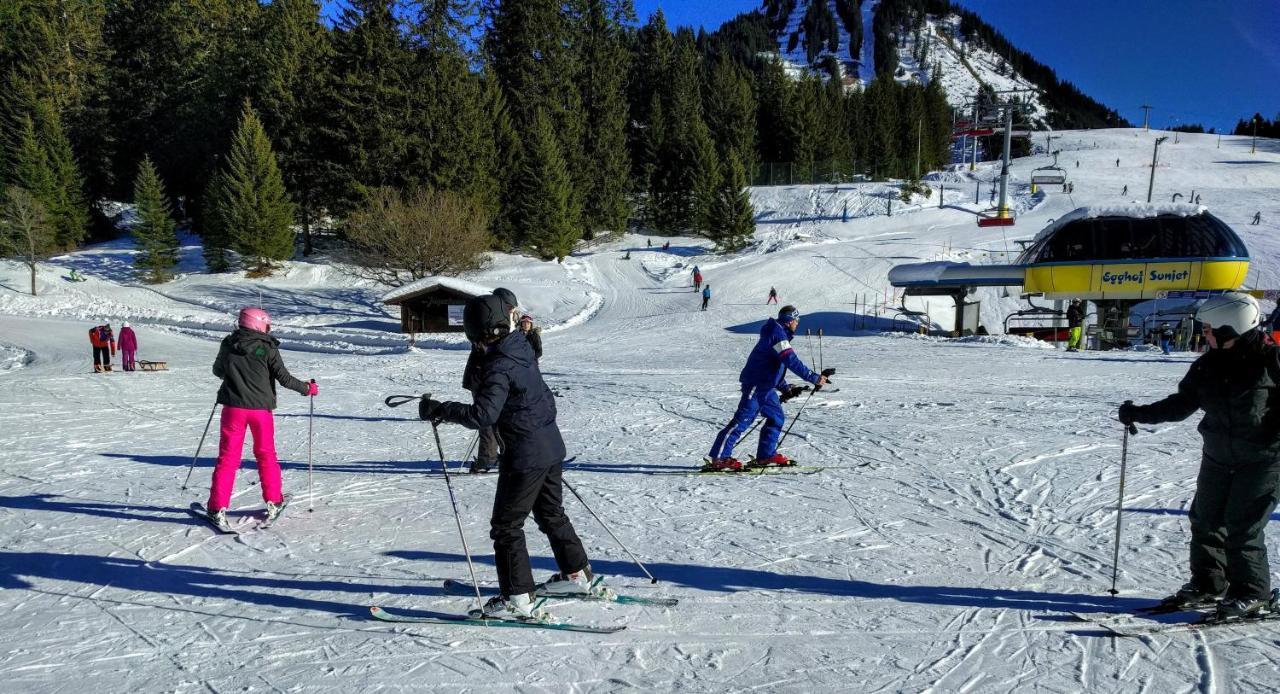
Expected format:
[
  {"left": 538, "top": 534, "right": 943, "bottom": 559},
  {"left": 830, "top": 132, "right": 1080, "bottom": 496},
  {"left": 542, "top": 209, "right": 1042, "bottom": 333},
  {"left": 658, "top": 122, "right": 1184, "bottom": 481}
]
[{"left": 212, "top": 101, "right": 293, "bottom": 273}]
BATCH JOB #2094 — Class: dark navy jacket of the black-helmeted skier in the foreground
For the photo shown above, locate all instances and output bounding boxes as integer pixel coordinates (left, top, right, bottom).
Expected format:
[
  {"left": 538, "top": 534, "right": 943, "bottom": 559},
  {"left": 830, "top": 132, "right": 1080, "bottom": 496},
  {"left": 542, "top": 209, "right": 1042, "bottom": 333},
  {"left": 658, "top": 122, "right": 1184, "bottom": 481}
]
[{"left": 434, "top": 330, "right": 564, "bottom": 471}]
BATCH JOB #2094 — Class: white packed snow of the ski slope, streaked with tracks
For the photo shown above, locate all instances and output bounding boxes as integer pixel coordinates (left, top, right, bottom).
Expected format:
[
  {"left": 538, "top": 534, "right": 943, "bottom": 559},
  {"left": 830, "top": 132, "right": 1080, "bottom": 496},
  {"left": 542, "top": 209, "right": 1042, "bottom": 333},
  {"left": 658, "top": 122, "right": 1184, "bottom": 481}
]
[{"left": 0, "top": 129, "right": 1280, "bottom": 693}]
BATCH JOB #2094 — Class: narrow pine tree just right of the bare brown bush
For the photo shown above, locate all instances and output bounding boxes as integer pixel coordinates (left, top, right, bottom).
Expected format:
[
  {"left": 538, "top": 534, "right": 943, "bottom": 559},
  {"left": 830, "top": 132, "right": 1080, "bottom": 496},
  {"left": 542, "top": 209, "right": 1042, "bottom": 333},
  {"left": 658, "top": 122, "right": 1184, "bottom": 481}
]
[{"left": 512, "top": 111, "right": 581, "bottom": 260}]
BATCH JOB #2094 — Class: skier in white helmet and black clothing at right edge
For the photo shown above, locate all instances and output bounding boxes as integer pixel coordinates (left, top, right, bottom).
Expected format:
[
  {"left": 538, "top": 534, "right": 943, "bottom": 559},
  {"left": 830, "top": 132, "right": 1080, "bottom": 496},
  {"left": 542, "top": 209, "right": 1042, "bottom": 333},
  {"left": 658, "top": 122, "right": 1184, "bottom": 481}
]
[{"left": 1120, "top": 292, "right": 1280, "bottom": 620}]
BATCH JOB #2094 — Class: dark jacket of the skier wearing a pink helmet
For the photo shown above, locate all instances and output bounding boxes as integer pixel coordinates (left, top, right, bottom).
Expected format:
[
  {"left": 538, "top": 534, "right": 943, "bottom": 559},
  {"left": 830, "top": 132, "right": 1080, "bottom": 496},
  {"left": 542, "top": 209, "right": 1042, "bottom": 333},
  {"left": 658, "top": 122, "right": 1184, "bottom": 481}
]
[{"left": 214, "top": 328, "right": 311, "bottom": 410}]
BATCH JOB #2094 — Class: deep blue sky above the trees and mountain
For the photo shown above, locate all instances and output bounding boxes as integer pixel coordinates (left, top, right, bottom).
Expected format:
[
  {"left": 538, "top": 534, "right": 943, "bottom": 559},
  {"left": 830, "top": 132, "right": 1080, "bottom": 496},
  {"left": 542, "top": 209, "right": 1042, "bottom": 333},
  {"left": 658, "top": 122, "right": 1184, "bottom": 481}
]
[{"left": 635, "top": 0, "right": 1280, "bottom": 129}]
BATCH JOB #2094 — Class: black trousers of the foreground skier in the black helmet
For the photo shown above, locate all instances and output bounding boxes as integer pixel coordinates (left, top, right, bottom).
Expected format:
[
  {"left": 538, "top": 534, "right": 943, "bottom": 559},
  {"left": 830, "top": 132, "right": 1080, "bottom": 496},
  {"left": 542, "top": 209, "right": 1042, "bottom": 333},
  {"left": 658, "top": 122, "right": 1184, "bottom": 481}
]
[{"left": 489, "top": 462, "right": 586, "bottom": 597}]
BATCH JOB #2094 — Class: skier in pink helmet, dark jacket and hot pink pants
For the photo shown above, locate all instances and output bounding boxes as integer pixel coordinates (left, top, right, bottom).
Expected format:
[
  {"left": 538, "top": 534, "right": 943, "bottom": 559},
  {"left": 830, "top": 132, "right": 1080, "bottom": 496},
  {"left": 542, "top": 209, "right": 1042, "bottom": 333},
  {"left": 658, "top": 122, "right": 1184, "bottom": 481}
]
[{"left": 207, "top": 307, "right": 320, "bottom": 528}]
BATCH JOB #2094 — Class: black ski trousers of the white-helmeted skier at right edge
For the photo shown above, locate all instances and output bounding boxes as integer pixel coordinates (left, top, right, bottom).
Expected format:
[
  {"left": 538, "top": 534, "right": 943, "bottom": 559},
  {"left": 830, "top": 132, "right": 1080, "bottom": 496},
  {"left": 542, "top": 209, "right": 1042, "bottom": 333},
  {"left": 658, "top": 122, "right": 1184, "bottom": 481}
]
[{"left": 1190, "top": 456, "right": 1280, "bottom": 599}]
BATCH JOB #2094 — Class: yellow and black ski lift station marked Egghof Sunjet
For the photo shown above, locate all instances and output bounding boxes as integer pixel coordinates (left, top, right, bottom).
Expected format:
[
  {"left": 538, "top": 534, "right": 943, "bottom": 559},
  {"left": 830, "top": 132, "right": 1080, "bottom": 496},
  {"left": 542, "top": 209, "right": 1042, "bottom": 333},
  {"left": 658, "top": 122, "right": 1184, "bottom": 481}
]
[{"left": 888, "top": 204, "right": 1249, "bottom": 334}]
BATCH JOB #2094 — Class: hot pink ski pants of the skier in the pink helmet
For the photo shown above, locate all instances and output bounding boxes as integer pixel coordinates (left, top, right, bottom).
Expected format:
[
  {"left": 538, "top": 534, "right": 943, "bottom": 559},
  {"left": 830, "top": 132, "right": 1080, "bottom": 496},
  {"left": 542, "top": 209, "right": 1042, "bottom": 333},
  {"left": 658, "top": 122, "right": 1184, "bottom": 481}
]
[{"left": 209, "top": 405, "right": 284, "bottom": 512}]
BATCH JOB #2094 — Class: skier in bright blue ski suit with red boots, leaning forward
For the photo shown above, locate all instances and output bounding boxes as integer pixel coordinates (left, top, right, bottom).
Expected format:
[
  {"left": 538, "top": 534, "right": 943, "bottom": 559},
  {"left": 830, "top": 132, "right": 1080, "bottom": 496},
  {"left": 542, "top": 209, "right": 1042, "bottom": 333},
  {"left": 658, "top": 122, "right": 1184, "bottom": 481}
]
[{"left": 708, "top": 306, "right": 827, "bottom": 470}]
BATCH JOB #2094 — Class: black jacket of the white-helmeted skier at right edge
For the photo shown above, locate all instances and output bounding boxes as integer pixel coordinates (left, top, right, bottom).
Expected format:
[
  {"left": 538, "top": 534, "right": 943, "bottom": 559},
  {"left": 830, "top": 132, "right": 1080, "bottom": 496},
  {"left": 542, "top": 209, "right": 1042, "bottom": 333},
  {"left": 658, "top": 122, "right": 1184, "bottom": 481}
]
[{"left": 1134, "top": 330, "right": 1280, "bottom": 467}]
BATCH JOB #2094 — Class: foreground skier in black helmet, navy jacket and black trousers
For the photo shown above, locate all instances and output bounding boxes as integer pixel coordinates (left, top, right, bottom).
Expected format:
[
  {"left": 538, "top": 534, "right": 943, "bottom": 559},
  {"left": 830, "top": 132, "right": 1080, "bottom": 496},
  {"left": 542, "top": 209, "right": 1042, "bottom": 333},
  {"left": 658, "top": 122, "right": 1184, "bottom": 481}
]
[{"left": 419, "top": 295, "right": 600, "bottom": 620}]
